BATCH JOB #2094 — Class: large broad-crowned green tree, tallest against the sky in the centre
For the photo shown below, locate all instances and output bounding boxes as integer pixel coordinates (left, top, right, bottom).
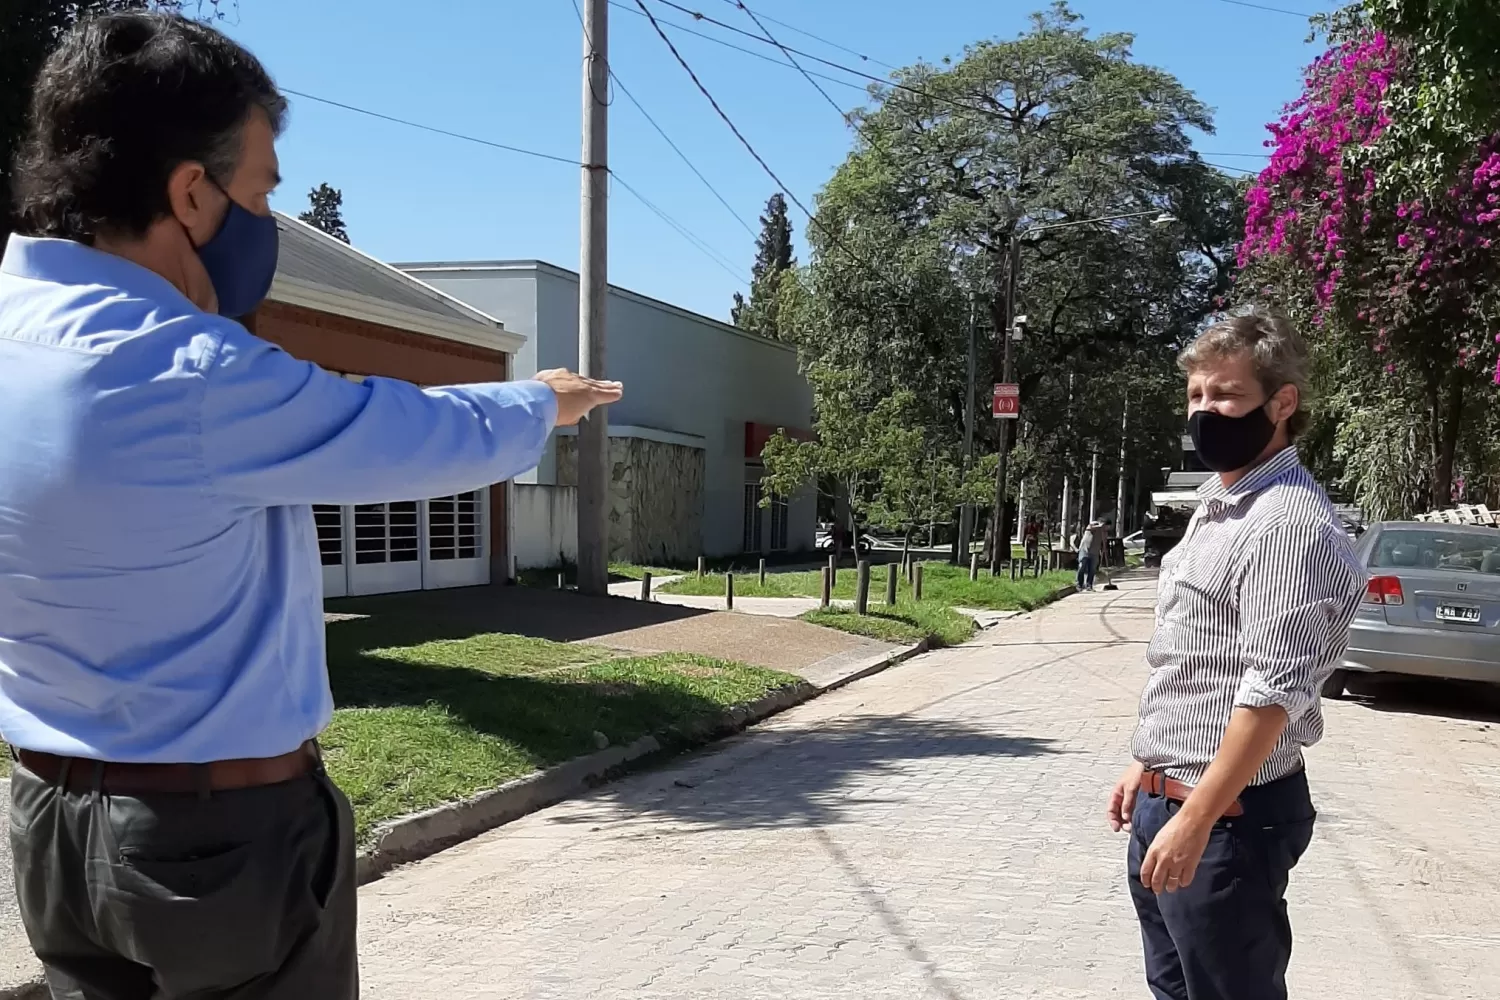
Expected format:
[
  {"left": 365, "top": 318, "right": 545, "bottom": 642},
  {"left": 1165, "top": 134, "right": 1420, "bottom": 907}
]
[{"left": 779, "top": 3, "right": 1244, "bottom": 554}]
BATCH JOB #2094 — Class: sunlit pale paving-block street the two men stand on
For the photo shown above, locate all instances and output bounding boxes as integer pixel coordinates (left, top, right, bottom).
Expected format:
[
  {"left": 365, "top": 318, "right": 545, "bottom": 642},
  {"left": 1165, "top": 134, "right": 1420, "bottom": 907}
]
[{"left": 362, "top": 577, "right": 1500, "bottom": 1000}]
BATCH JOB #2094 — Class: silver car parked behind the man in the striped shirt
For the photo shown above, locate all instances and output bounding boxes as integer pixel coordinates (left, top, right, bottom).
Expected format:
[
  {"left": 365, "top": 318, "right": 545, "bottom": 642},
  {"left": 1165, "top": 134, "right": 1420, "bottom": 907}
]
[{"left": 1323, "top": 522, "right": 1500, "bottom": 697}]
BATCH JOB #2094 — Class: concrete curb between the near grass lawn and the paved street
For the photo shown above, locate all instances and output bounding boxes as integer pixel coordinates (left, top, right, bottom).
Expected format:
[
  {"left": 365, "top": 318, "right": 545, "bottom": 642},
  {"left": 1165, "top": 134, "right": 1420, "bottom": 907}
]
[{"left": 354, "top": 639, "right": 930, "bottom": 887}]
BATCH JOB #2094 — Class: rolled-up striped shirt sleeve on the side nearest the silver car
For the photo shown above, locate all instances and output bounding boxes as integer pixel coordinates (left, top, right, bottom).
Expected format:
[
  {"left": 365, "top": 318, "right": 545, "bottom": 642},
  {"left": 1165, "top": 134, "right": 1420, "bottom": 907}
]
[{"left": 1235, "top": 525, "right": 1364, "bottom": 721}]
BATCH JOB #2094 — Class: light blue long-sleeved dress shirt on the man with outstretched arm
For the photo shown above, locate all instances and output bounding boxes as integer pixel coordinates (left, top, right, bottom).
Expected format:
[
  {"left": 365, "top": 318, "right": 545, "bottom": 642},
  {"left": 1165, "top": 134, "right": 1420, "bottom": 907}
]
[{"left": 0, "top": 237, "right": 557, "bottom": 763}]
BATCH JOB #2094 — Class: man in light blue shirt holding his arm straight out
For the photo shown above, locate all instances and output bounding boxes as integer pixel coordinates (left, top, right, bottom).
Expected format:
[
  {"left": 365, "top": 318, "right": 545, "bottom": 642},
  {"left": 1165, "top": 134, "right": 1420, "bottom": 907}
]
[{"left": 0, "top": 15, "right": 620, "bottom": 1000}]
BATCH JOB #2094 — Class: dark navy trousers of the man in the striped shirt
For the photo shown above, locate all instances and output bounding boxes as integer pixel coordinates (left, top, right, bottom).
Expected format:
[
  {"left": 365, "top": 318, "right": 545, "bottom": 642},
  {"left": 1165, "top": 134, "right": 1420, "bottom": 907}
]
[{"left": 1128, "top": 771, "right": 1317, "bottom": 1000}]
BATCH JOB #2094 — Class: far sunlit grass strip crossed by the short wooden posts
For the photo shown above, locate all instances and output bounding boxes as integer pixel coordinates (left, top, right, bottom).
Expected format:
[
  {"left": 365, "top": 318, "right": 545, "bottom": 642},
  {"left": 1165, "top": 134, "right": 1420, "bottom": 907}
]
[{"left": 662, "top": 562, "right": 1074, "bottom": 612}]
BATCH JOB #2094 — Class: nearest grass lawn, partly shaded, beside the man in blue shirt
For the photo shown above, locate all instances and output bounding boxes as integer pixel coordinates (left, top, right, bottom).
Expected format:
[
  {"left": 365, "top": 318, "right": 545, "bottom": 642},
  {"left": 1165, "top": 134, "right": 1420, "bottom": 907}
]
[{"left": 323, "top": 619, "right": 795, "bottom": 843}]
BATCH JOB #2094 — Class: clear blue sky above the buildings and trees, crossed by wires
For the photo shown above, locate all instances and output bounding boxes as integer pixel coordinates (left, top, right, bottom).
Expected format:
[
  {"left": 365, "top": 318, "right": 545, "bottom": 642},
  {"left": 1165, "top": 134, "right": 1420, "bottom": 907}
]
[{"left": 227, "top": 0, "right": 1335, "bottom": 318}]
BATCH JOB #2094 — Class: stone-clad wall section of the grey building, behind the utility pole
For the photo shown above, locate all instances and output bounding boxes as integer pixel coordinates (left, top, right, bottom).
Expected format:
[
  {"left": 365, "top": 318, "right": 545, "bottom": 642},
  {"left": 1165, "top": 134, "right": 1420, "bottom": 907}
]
[{"left": 557, "top": 436, "right": 704, "bottom": 565}]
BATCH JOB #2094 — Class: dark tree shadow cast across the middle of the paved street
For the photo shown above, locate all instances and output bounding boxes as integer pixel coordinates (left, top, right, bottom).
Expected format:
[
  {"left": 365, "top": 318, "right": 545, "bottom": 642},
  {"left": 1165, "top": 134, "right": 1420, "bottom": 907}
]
[{"left": 552, "top": 717, "right": 1064, "bottom": 829}]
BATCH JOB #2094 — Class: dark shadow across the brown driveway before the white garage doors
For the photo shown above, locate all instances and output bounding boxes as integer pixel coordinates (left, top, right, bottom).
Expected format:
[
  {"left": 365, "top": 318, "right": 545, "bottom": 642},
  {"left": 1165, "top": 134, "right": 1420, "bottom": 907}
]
[{"left": 324, "top": 586, "right": 710, "bottom": 651}]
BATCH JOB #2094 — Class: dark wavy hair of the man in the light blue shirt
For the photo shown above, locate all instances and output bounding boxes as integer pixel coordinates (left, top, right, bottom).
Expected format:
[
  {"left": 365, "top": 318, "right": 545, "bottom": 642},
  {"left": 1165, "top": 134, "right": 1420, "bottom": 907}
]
[{"left": 12, "top": 13, "right": 287, "bottom": 243}]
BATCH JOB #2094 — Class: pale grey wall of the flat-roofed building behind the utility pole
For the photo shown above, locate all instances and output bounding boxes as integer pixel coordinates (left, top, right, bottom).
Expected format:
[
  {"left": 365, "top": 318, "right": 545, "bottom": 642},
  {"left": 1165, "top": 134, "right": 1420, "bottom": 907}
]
[{"left": 405, "top": 262, "right": 816, "bottom": 556}]
